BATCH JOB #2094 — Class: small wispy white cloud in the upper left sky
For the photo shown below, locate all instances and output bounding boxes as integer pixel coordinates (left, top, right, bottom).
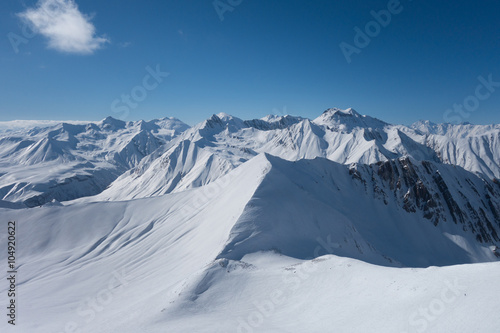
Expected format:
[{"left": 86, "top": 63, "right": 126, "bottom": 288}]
[{"left": 19, "top": 0, "right": 109, "bottom": 54}]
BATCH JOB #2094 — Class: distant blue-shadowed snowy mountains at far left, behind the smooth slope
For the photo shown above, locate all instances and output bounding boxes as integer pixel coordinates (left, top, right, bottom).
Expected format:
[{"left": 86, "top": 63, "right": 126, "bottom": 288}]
[{"left": 0, "top": 117, "right": 187, "bottom": 207}]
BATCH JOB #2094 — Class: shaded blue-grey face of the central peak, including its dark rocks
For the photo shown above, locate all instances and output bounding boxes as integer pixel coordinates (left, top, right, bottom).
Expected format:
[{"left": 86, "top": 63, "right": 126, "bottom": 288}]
[{"left": 219, "top": 155, "right": 500, "bottom": 267}]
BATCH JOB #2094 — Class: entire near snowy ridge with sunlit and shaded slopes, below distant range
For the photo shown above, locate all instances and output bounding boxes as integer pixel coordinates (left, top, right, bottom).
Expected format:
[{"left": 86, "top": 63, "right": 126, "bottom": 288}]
[{"left": 0, "top": 154, "right": 500, "bottom": 332}]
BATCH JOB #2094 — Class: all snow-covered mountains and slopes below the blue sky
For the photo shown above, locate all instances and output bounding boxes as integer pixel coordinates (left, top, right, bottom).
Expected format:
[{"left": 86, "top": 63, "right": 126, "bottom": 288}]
[{"left": 0, "top": 109, "right": 500, "bottom": 333}]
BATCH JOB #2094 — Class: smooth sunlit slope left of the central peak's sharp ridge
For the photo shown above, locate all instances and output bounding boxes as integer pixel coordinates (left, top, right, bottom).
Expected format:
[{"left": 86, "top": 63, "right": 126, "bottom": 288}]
[{"left": 0, "top": 160, "right": 267, "bottom": 332}]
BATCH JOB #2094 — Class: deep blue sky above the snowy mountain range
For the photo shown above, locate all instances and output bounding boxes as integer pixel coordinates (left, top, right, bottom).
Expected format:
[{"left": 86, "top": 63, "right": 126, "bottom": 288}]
[{"left": 0, "top": 0, "right": 500, "bottom": 124}]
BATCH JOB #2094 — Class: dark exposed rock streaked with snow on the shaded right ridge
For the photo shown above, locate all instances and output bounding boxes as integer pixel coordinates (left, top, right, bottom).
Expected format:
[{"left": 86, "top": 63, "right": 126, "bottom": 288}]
[{"left": 349, "top": 158, "right": 500, "bottom": 244}]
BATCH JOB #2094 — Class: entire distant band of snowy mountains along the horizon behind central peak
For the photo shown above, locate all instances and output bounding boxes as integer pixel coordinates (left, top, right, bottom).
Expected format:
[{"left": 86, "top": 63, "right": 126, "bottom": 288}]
[{"left": 0, "top": 109, "right": 500, "bottom": 206}]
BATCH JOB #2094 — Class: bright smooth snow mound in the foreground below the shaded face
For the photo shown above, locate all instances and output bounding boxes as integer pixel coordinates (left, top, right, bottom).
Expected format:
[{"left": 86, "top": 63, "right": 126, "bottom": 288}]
[{"left": 163, "top": 253, "right": 500, "bottom": 333}]
